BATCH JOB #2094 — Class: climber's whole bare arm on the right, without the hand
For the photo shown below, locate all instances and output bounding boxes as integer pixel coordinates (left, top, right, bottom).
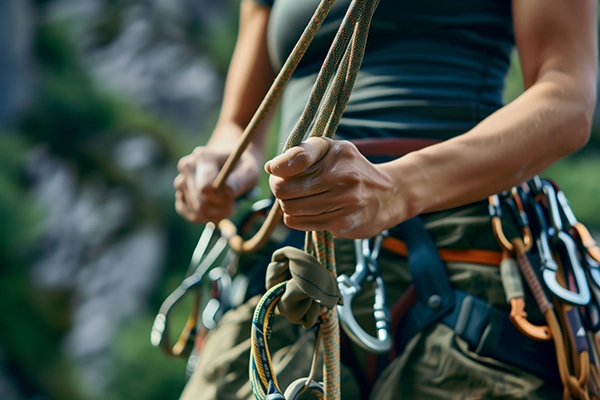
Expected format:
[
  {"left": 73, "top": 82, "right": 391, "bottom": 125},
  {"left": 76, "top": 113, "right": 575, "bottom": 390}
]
[{"left": 389, "top": 0, "right": 598, "bottom": 214}]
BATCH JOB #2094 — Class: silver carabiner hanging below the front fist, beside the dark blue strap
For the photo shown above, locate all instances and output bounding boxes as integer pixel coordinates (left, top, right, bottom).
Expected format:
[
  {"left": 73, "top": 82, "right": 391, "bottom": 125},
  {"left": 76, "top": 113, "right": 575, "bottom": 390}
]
[{"left": 338, "top": 231, "right": 392, "bottom": 353}]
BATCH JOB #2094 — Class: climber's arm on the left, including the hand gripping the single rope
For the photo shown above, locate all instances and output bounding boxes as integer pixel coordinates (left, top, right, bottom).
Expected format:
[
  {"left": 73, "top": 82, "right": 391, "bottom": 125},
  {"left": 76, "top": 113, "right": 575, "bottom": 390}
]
[{"left": 174, "top": 0, "right": 275, "bottom": 222}]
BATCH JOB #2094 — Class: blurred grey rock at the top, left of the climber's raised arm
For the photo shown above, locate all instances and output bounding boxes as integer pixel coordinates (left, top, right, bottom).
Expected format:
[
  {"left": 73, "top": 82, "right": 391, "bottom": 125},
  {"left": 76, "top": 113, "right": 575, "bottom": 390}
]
[{"left": 49, "top": 0, "right": 226, "bottom": 131}]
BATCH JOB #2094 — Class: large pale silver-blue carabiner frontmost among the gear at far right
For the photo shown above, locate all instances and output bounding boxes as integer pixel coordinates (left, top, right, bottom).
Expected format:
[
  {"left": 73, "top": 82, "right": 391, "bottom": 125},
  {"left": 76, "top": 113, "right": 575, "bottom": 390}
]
[{"left": 540, "top": 231, "right": 591, "bottom": 306}]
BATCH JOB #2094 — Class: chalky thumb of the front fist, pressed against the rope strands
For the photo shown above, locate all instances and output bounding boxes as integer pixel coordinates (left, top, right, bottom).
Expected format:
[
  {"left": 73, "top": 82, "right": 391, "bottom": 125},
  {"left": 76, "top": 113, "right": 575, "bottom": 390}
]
[{"left": 265, "top": 137, "right": 333, "bottom": 178}]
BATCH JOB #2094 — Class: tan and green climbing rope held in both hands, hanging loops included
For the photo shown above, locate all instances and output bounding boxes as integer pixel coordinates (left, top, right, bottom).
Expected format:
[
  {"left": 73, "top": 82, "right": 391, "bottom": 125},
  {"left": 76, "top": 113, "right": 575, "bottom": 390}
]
[{"left": 213, "top": 0, "right": 379, "bottom": 400}]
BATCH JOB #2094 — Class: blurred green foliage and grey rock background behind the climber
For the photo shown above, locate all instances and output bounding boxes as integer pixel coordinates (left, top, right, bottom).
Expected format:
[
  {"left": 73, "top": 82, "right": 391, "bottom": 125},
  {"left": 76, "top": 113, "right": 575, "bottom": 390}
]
[{"left": 0, "top": 0, "right": 600, "bottom": 400}]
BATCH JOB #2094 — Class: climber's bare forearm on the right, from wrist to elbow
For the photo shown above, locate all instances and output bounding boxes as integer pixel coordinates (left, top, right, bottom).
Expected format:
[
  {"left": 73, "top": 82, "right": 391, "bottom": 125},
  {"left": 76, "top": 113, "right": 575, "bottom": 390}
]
[{"left": 384, "top": 73, "right": 595, "bottom": 221}]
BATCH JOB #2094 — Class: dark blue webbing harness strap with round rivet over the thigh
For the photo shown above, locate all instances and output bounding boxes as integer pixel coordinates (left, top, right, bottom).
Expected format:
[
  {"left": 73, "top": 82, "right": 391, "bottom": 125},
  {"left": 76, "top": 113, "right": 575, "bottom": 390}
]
[{"left": 390, "top": 218, "right": 560, "bottom": 382}]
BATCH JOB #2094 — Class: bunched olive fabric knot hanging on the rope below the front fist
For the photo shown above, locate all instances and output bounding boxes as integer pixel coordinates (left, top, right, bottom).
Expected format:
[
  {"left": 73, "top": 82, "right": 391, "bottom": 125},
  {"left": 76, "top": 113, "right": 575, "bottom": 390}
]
[{"left": 266, "top": 246, "right": 342, "bottom": 328}]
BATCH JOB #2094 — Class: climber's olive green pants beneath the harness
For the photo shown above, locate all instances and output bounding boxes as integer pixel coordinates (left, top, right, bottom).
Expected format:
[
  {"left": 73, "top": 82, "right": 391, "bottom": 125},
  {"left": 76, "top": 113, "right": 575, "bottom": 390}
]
[{"left": 181, "top": 203, "right": 561, "bottom": 400}]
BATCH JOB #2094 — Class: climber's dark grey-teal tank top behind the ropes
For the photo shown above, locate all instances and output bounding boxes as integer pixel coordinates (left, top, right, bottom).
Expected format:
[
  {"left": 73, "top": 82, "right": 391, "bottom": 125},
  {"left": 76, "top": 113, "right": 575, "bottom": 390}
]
[{"left": 254, "top": 0, "right": 514, "bottom": 139}]
